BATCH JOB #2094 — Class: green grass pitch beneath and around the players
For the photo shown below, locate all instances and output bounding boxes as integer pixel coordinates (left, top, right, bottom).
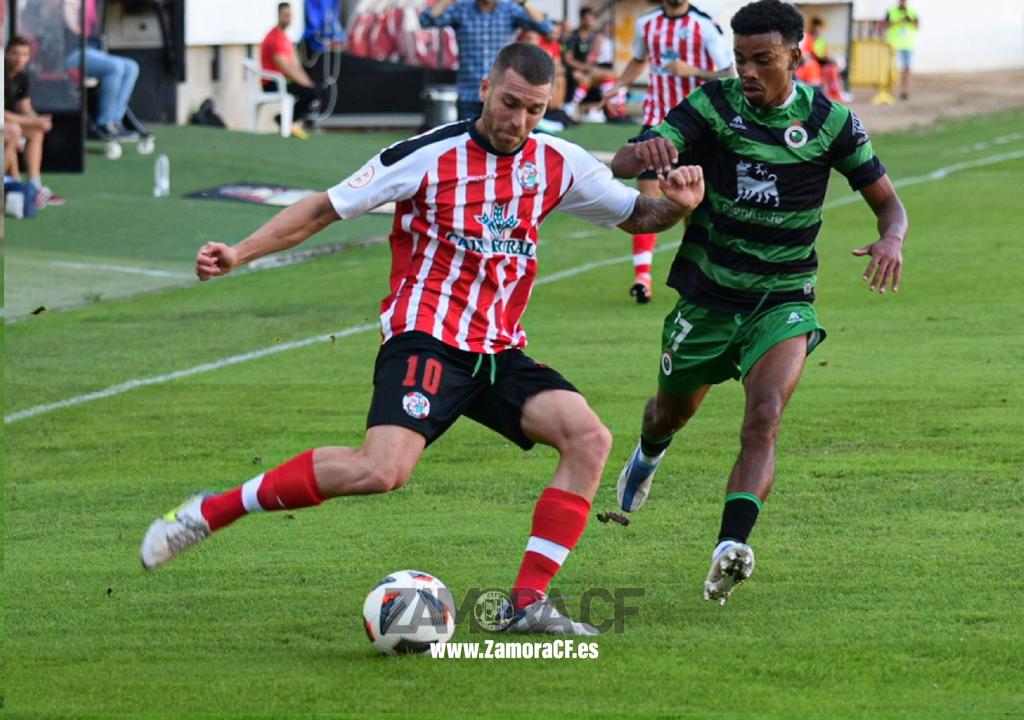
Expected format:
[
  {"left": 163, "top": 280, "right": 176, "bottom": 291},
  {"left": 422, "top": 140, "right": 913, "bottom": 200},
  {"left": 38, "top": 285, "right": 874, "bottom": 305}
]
[{"left": 2, "top": 112, "right": 1024, "bottom": 718}]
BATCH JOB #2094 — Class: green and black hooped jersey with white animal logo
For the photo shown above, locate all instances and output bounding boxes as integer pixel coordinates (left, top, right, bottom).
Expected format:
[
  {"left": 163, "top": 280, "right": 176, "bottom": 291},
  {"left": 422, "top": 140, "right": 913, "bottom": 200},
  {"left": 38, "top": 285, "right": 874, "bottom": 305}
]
[{"left": 640, "top": 78, "right": 886, "bottom": 312}]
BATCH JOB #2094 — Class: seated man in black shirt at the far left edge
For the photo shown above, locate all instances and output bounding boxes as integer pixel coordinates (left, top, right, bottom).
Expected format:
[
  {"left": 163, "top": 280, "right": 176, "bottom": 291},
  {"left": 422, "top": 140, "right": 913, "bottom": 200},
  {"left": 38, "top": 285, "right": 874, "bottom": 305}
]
[{"left": 3, "top": 35, "right": 63, "bottom": 208}]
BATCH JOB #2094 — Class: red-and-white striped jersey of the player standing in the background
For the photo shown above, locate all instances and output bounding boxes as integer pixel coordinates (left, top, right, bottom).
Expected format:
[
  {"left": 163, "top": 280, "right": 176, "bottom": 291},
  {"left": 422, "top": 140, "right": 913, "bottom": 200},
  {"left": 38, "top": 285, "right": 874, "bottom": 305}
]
[{"left": 633, "top": 5, "right": 732, "bottom": 127}]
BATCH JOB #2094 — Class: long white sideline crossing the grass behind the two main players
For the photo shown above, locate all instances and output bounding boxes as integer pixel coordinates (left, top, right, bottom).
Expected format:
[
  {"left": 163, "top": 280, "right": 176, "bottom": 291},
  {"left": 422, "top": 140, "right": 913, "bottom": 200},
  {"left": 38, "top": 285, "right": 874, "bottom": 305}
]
[{"left": 3, "top": 151, "right": 1024, "bottom": 425}]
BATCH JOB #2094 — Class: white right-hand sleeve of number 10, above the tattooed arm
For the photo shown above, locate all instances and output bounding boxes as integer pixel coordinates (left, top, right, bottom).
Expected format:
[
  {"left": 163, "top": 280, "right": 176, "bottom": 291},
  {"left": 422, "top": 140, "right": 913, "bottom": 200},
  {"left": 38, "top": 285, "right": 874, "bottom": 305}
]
[{"left": 557, "top": 142, "right": 640, "bottom": 227}]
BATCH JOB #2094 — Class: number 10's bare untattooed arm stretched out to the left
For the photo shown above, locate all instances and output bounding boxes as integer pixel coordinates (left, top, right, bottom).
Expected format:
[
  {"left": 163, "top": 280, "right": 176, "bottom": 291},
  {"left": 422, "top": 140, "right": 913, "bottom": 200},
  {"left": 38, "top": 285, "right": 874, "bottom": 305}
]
[{"left": 196, "top": 193, "right": 340, "bottom": 281}]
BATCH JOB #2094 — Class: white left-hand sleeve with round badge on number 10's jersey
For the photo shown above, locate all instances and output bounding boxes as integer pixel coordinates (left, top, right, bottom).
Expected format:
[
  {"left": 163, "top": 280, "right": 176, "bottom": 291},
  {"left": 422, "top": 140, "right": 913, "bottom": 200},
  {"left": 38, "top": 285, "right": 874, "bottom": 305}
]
[{"left": 327, "top": 150, "right": 426, "bottom": 220}]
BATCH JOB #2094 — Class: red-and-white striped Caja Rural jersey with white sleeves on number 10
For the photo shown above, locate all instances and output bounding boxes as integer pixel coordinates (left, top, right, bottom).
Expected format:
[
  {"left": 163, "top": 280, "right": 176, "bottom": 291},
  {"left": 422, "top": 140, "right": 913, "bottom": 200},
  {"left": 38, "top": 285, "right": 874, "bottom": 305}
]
[{"left": 328, "top": 120, "right": 638, "bottom": 353}]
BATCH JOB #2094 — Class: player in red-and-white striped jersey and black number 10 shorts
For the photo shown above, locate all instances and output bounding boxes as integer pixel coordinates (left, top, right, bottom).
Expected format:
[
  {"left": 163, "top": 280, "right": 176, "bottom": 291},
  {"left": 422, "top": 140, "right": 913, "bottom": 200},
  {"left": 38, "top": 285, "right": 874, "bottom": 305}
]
[{"left": 141, "top": 43, "right": 703, "bottom": 634}]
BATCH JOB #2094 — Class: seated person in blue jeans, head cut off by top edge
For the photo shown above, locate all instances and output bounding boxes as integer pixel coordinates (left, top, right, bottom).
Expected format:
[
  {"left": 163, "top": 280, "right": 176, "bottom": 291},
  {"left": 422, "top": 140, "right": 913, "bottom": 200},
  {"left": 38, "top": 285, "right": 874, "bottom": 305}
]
[{"left": 65, "top": 0, "right": 138, "bottom": 140}]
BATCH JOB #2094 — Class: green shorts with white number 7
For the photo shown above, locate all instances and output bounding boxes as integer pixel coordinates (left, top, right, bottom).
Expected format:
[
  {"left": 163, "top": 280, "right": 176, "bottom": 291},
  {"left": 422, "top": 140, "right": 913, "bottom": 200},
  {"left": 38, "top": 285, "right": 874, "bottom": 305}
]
[{"left": 658, "top": 298, "right": 825, "bottom": 395}]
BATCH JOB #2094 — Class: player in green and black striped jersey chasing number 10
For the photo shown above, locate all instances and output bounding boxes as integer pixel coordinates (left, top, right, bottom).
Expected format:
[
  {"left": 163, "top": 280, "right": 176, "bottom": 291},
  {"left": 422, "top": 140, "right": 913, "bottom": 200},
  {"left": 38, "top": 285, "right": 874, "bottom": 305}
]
[{"left": 612, "top": 0, "right": 907, "bottom": 603}]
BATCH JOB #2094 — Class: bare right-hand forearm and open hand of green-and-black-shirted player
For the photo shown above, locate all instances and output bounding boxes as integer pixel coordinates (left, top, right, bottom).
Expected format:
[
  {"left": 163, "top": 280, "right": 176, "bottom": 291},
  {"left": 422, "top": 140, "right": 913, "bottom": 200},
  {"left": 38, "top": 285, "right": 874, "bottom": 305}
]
[{"left": 853, "top": 175, "right": 909, "bottom": 293}]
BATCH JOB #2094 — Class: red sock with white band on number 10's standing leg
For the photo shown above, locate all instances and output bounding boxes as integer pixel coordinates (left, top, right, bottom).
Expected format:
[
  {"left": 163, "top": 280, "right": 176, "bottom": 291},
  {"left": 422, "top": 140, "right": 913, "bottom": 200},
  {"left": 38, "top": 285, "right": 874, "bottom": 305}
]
[{"left": 512, "top": 488, "right": 590, "bottom": 610}]
